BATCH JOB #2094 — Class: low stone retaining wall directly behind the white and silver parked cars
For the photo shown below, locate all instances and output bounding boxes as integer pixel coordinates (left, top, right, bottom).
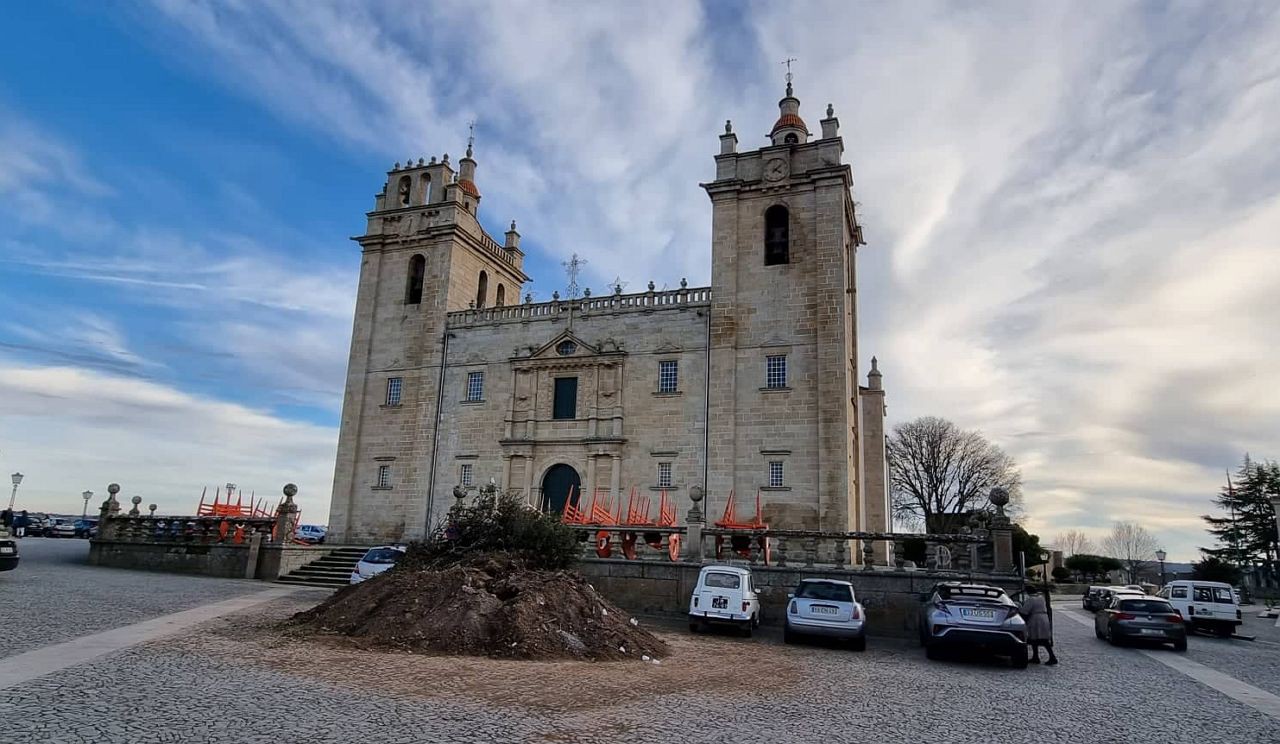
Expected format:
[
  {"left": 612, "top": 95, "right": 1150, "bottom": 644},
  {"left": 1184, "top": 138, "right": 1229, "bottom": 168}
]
[{"left": 577, "top": 558, "right": 1021, "bottom": 638}]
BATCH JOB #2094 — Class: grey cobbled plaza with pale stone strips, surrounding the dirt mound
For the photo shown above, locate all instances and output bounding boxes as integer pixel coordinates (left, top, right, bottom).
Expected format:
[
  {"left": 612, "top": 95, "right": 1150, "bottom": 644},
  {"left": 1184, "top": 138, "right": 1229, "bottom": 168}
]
[{"left": 0, "top": 539, "right": 1280, "bottom": 744}]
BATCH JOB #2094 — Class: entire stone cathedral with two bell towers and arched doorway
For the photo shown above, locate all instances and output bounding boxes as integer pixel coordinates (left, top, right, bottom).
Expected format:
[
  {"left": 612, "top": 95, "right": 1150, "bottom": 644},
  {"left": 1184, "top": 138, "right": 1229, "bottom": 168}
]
[{"left": 329, "top": 82, "right": 890, "bottom": 543}]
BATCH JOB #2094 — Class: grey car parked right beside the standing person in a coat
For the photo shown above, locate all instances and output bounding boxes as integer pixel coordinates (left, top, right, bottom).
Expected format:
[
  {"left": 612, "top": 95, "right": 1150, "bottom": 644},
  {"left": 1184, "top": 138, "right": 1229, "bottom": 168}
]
[{"left": 919, "top": 581, "right": 1027, "bottom": 668}]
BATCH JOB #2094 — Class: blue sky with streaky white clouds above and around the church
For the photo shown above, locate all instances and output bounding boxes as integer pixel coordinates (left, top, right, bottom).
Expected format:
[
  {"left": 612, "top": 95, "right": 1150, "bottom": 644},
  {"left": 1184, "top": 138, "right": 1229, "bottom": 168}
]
[{"left": 0, "top": 0, "right": 1280, "bottom": 560}]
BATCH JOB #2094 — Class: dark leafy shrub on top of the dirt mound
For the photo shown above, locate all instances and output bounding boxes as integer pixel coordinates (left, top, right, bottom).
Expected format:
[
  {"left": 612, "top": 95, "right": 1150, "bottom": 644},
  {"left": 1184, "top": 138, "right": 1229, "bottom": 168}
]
[{"left": 399, "top": 489, "right": 581, "bottom": 570}]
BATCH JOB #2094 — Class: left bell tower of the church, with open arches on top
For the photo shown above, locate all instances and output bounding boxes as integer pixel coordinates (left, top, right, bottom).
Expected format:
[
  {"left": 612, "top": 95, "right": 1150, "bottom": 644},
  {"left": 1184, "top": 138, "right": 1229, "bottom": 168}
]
[{"left": 329, "top": 141, "right": 529, "bottom": 543}]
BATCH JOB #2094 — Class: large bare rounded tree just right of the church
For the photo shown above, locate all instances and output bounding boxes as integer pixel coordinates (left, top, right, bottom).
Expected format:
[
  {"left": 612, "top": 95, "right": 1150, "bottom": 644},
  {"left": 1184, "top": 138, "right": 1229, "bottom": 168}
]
[{"left": 888, "top": 416, "right": 1021, "bottom": 529}]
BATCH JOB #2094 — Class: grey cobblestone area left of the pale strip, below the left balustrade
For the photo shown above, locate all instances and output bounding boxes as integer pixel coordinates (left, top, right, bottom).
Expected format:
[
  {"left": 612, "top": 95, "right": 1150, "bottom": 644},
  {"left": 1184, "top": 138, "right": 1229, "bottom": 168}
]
[{"left": 0, "top": 538, "right": 262, "bottom": 655}]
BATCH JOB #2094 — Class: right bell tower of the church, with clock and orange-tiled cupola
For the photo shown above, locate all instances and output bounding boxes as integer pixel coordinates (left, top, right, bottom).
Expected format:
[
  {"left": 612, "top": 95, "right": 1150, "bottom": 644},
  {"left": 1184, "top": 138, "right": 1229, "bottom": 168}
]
[{"left": 701, "top": 75, "right": 865, "bottom": 531}]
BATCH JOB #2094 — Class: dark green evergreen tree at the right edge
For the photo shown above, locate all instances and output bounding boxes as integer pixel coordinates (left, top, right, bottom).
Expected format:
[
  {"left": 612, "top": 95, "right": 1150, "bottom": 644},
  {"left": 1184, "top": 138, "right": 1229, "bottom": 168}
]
[{"left": 1201, "top": 455, "right": 1280, "bottom": 574}]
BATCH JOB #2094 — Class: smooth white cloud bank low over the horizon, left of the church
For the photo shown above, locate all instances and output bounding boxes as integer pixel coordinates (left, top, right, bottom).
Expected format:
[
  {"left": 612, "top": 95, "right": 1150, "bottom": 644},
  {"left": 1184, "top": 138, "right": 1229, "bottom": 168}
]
[{"left": 0, "top": 362, "right": 337, "bottom": 520}]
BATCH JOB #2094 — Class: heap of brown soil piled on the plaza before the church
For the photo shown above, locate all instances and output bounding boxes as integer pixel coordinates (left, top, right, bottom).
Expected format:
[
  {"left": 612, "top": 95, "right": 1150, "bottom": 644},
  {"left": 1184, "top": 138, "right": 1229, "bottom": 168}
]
[{"left": 291, "top": 558, "right": 667, "bottom": 659}]
